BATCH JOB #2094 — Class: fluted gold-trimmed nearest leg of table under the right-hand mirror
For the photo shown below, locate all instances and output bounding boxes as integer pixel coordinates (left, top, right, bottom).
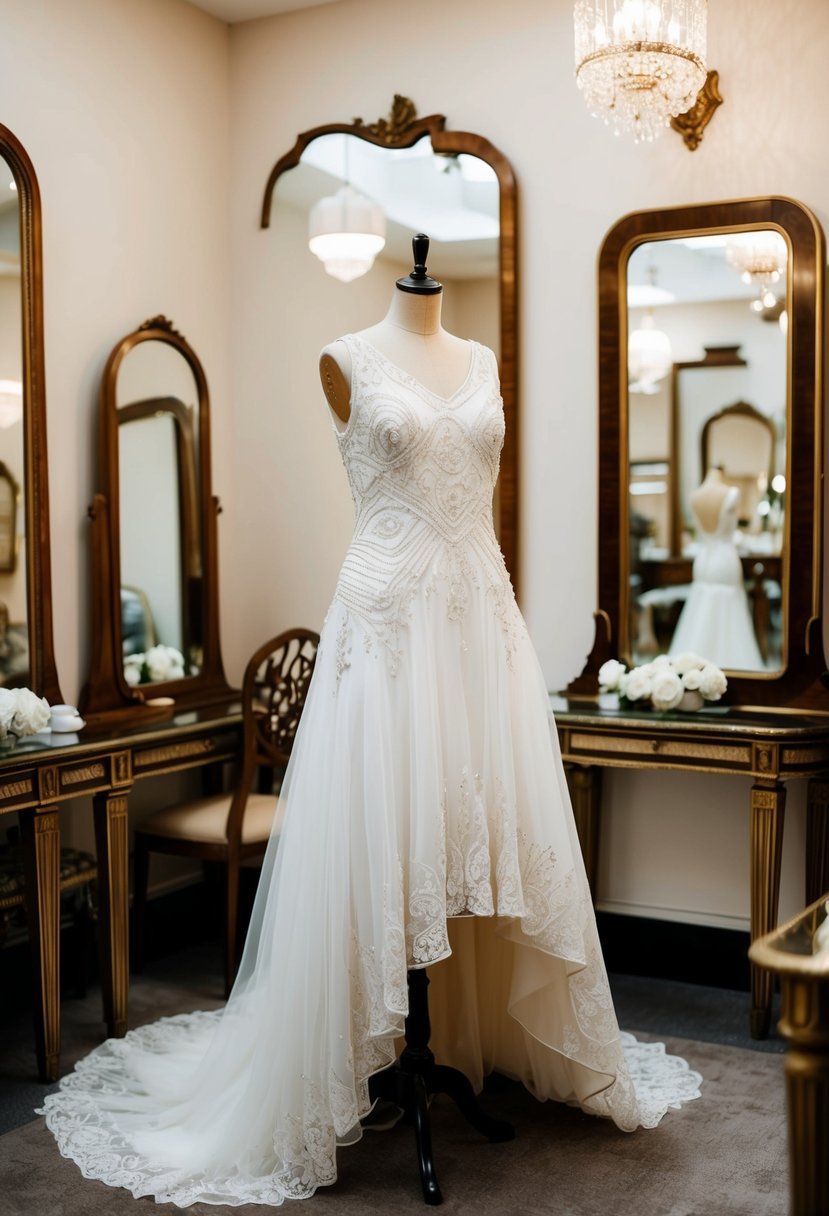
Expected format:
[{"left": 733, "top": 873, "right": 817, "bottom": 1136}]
[{"left": 749, "top": 781, "right": 785, "bottom": 1038}]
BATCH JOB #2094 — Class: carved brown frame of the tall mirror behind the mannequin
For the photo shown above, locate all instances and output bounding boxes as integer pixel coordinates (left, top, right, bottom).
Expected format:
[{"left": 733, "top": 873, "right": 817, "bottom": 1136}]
[{"left": 261, "top": 94, "right": 519, "bottom": 592}]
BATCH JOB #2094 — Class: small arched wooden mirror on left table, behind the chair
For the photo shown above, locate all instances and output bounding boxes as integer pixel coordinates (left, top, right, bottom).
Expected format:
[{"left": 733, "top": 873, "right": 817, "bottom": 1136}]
[{"left": 83, "top": 317, "right": 231, "bottom": 725}]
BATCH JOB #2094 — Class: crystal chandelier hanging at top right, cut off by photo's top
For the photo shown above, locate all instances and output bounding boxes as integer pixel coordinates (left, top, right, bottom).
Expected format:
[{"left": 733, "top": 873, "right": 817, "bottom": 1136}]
[{"left": 575, "top": 0, "right": 707, "bottom": 143}]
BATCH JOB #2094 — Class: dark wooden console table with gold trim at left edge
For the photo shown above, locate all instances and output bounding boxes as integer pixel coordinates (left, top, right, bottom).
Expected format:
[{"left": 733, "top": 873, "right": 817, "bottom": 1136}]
[{"left": 6, "top": 704, "right": 242, "bottom": 1081}]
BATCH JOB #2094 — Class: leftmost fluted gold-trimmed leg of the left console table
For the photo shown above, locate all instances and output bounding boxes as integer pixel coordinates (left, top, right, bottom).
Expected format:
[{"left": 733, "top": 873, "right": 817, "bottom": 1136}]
[{"left": 19, "top": 806, "right": 61, "bottom": 1081}]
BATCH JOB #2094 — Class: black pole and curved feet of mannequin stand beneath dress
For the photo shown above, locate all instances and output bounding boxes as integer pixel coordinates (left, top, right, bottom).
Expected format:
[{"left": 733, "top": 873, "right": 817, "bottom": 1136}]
[{"left": 368, "top": 968, "right": 515, "bottom": 1206}]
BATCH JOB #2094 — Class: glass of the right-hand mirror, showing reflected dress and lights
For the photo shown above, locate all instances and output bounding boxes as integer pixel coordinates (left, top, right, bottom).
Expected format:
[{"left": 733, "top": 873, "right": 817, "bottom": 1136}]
[{"left": 627, "top": 229, "right": 789, "bottom": 674}]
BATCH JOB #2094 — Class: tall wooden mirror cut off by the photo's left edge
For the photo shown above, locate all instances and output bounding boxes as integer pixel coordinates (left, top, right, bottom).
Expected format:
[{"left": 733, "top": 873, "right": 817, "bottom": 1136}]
[{"left": 0, "top": 126, "right": 62, "bottom": 704}]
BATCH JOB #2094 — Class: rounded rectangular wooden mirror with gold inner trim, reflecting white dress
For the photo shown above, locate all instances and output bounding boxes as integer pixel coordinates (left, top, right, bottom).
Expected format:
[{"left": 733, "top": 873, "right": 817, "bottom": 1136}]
[{"left": 569, "top": 198, "right": 829, "bottom": 708}]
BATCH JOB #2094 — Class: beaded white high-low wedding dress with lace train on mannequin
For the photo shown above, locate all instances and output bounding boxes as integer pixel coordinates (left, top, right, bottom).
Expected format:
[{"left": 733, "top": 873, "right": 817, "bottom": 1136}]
[{"left": 38, "top": 337, "right": 700, "bottom": 1206}]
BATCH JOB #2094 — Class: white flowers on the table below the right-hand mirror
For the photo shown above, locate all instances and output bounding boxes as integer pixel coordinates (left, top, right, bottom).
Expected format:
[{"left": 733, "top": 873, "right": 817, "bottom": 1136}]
[{"left": 599, "top": 654, "right": 728, "bottom": 713}]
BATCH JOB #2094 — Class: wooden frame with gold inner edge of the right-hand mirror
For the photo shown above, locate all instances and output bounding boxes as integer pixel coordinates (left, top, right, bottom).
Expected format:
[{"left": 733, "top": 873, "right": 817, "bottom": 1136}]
[{"left": 566, "top": 196, "right": 829, "bottom": 711}]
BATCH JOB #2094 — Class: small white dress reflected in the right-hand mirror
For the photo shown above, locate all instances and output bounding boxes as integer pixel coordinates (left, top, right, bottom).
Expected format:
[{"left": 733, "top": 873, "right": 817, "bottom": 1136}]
[{"left": 671, "top": 485, "right": 765, "bottom": 671}]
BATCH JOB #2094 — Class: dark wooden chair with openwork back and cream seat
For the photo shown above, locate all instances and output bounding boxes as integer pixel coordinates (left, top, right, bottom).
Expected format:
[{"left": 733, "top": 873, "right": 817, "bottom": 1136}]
[{"left": 132, "top": 629, "right": 320, "bottom": 995}]
